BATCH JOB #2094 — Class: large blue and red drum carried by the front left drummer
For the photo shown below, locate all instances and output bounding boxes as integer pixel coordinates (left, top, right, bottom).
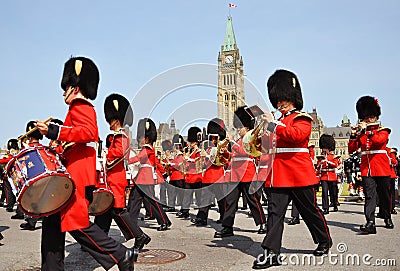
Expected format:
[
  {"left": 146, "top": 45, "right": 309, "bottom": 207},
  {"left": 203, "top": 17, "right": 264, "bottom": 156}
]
[{"left": 6, "top": 146, "right": 75, "bottom": 218}]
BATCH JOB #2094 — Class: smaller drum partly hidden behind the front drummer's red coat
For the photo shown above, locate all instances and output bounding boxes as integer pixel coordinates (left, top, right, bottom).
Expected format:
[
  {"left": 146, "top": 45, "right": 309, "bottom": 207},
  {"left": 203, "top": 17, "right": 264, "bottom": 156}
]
[{"left": 89, "top": 171, "right": 114, "bottom": 216}]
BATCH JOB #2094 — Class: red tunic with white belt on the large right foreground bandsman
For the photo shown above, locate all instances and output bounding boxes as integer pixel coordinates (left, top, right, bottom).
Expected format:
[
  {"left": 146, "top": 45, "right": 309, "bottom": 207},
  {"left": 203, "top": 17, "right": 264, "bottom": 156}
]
[{"left": 265, "top": 111, "right": 318, "bottom": 187}]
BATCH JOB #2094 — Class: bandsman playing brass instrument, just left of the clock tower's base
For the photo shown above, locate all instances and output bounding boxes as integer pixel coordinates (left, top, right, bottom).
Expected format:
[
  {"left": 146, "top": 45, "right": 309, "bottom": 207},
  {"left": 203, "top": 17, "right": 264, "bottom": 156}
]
[{"left": 191, "top": 118, "right": 230, "bottom": 226}]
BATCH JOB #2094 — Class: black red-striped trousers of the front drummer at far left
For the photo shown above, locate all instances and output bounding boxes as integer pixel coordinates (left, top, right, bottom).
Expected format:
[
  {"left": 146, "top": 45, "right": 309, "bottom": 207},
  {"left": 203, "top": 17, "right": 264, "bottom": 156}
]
[{"left": 41, "top": 213, "right": 127, "bottom": 271}]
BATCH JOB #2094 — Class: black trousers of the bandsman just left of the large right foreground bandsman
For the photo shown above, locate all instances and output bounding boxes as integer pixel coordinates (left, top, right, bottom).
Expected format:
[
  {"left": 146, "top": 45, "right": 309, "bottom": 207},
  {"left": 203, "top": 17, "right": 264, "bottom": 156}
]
[{"left": 222, "top": 182, "right": 266, "bottom": 228}]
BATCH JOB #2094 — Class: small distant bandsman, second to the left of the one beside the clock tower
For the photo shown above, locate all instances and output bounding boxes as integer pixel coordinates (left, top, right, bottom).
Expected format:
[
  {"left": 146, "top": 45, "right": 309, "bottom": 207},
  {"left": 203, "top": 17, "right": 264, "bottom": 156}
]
[{"left": 167, "top": 134, "right": 185, "bottom": 212}]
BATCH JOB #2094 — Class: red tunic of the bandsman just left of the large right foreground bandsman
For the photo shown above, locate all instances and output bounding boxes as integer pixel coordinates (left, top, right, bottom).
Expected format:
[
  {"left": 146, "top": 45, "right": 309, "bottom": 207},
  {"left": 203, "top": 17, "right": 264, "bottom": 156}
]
[{"left": 230, "top": 138, "right": 256, "bottom": 182}]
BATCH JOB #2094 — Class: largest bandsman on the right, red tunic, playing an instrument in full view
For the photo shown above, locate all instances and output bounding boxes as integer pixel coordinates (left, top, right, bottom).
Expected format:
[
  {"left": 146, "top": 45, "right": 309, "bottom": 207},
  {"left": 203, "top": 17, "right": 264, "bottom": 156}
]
[{"left": 253, "top": 70, "right": 332, "bottom": 269}]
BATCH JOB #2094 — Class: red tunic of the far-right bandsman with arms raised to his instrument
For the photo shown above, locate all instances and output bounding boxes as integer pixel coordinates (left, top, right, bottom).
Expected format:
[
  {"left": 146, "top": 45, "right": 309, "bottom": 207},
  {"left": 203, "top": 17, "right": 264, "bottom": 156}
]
[{"left": 348, "top": 127, "right": 390, "bottom": 177}]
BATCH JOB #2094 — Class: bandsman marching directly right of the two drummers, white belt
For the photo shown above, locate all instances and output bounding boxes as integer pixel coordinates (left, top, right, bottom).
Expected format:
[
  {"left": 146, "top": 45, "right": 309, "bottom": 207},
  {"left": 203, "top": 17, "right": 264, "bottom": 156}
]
[{"left": 128, "top": 118, "right": 172, "bottom": 231}]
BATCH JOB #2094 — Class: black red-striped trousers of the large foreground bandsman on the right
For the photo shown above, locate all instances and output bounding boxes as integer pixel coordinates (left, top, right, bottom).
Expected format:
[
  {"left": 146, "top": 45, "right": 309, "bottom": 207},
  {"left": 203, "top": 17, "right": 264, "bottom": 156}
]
[{"left": 261, "top": 186, "right": 331, "bottom": 254}]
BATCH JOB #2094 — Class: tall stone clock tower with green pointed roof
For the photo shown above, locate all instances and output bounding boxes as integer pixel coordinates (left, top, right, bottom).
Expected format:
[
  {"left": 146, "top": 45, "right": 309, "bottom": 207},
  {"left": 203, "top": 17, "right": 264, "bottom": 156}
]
[{"left": 218, "top": 16, "right": 245, "bottom": 132}]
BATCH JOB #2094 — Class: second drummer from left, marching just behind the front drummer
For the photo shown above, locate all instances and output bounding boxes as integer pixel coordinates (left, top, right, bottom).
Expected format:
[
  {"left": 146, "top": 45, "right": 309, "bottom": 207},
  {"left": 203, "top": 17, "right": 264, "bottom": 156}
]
[{"left": 94, "top": 93, "right": 151, "bottom": 253}]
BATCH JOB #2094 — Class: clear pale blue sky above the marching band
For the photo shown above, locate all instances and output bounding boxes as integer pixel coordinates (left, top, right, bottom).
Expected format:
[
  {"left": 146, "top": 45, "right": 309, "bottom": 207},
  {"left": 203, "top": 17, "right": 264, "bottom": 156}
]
[{"left": 0, "top": 0, "right": 400, "bottom": 149}]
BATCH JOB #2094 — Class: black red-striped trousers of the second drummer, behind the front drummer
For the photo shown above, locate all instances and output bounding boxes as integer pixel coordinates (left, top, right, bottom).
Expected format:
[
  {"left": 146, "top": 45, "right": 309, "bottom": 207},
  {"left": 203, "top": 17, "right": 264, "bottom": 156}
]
[{"left": 94, "top": 208, "right": 143, "bottom": 241}]
